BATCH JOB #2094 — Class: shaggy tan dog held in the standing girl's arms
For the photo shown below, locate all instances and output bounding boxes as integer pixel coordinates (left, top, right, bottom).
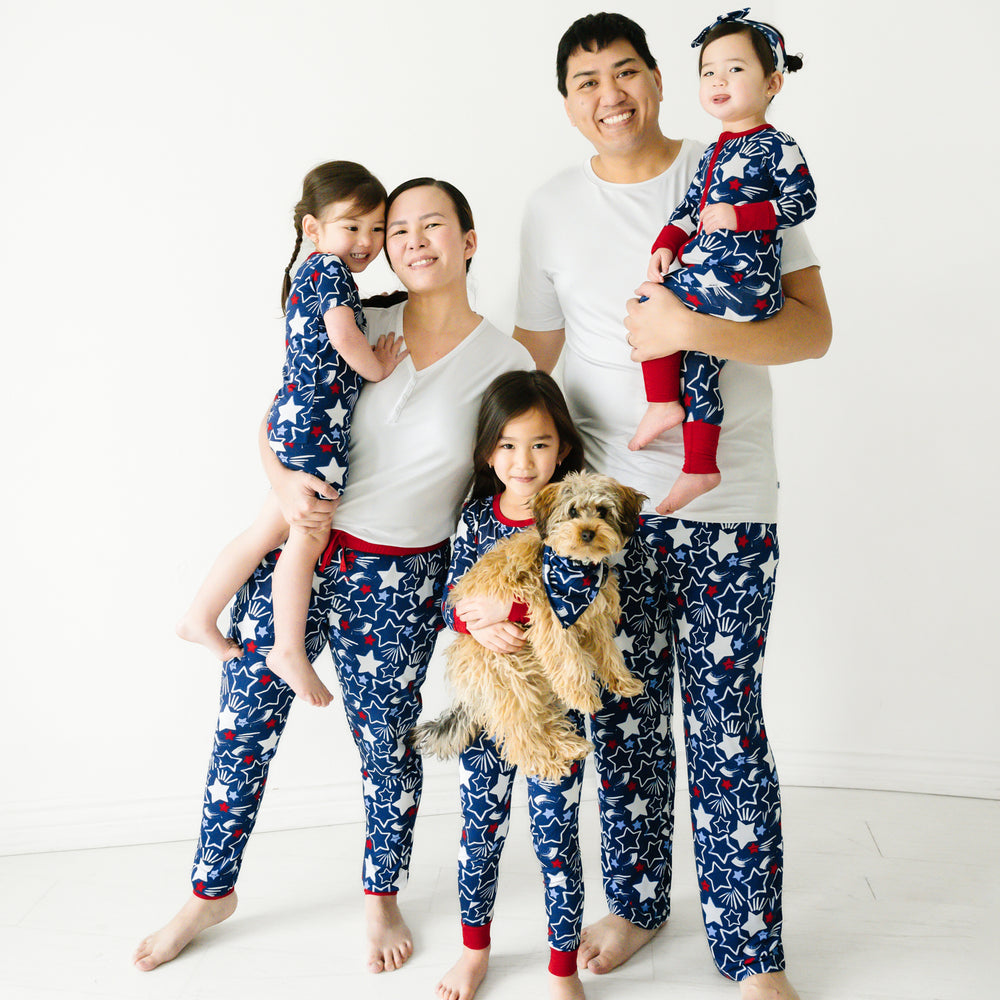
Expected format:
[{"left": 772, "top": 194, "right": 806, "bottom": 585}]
[{"left": 408, "top": 472, "right": 646, "bottom": 781}]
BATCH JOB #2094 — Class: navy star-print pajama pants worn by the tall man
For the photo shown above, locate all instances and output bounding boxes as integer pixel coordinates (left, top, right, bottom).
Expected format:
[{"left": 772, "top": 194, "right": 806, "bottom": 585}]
[{"left": 592, "top": 515, "right": 784, "bottom": 980}]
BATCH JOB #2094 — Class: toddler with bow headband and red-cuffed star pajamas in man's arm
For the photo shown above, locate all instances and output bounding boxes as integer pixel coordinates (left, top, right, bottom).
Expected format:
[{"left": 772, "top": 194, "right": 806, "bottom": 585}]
[{"left": 629, "top": 7, "right": 816, "bottom": 514}]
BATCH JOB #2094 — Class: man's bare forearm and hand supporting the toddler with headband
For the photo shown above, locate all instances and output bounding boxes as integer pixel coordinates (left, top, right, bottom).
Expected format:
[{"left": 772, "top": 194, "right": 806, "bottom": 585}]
[{"left": 628, "top": 267, "right": 833, "bottom": 365}]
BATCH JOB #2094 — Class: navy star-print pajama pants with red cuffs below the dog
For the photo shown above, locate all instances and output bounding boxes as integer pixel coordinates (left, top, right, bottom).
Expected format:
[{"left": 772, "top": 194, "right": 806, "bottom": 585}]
[{"left": 458, "top": 713, "right": 584, "bottom": 975}]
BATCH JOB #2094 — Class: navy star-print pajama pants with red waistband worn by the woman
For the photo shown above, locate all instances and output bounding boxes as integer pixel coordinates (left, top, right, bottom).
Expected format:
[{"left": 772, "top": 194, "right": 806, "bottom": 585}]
[{"left": 192, "top": 544, "right": 448, "bottom": 899}]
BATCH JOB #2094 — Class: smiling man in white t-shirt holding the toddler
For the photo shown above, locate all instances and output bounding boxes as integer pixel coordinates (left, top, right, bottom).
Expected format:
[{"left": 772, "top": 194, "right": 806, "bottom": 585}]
[{"left": 514, "top": 14, "right": 831, "bottom": 1000}]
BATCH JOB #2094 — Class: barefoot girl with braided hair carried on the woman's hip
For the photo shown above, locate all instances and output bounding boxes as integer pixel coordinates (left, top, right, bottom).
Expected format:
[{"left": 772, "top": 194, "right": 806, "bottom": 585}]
[{"left": 177, "top": 160, "right": 406, "bottom": 706}]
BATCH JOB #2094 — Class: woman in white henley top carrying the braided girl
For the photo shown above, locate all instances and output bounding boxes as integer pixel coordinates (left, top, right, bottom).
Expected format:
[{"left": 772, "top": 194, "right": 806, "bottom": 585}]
[{"left": 133, "top": 177, "right": 532, "bottom": 972}]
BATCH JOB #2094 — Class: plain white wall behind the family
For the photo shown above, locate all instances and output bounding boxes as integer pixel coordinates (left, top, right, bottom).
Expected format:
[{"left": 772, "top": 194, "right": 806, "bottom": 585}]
[{"left": 0, "top": 0, "right": 1000, "bottom": 852}]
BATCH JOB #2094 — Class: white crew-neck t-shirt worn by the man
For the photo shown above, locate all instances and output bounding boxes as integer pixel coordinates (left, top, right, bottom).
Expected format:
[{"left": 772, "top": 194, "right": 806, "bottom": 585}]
[{"left": 515, "top": 139, "right": 818, "bottom": 522}]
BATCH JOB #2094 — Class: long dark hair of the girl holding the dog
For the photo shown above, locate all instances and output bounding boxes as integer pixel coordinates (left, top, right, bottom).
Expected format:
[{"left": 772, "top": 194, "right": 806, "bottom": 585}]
[{"left": 471, "top": 371, "right": 583, "bottom": 500}]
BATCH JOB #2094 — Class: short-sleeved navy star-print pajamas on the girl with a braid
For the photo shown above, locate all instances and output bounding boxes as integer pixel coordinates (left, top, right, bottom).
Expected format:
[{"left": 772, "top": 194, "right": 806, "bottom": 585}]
[{"left": 267, "top": 253, "right": 367, "bottom": 489}]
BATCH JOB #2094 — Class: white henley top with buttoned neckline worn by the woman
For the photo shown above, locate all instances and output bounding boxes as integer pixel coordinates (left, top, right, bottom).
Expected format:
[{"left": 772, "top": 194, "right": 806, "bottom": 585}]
[{"left": 333, "top": 303, "right": 534, "bottom": 548}]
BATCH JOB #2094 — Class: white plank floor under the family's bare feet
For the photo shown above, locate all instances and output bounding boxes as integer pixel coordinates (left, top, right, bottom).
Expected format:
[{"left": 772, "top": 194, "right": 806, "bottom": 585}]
[{"left": 0, "top": 787, "right": 1000, "bottom": 1000}]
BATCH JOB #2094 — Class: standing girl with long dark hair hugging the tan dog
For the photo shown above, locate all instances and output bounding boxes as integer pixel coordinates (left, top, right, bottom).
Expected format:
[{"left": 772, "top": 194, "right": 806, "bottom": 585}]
[{"left": 437, "top": 371, "right": 596, "bottom": 1000}]
